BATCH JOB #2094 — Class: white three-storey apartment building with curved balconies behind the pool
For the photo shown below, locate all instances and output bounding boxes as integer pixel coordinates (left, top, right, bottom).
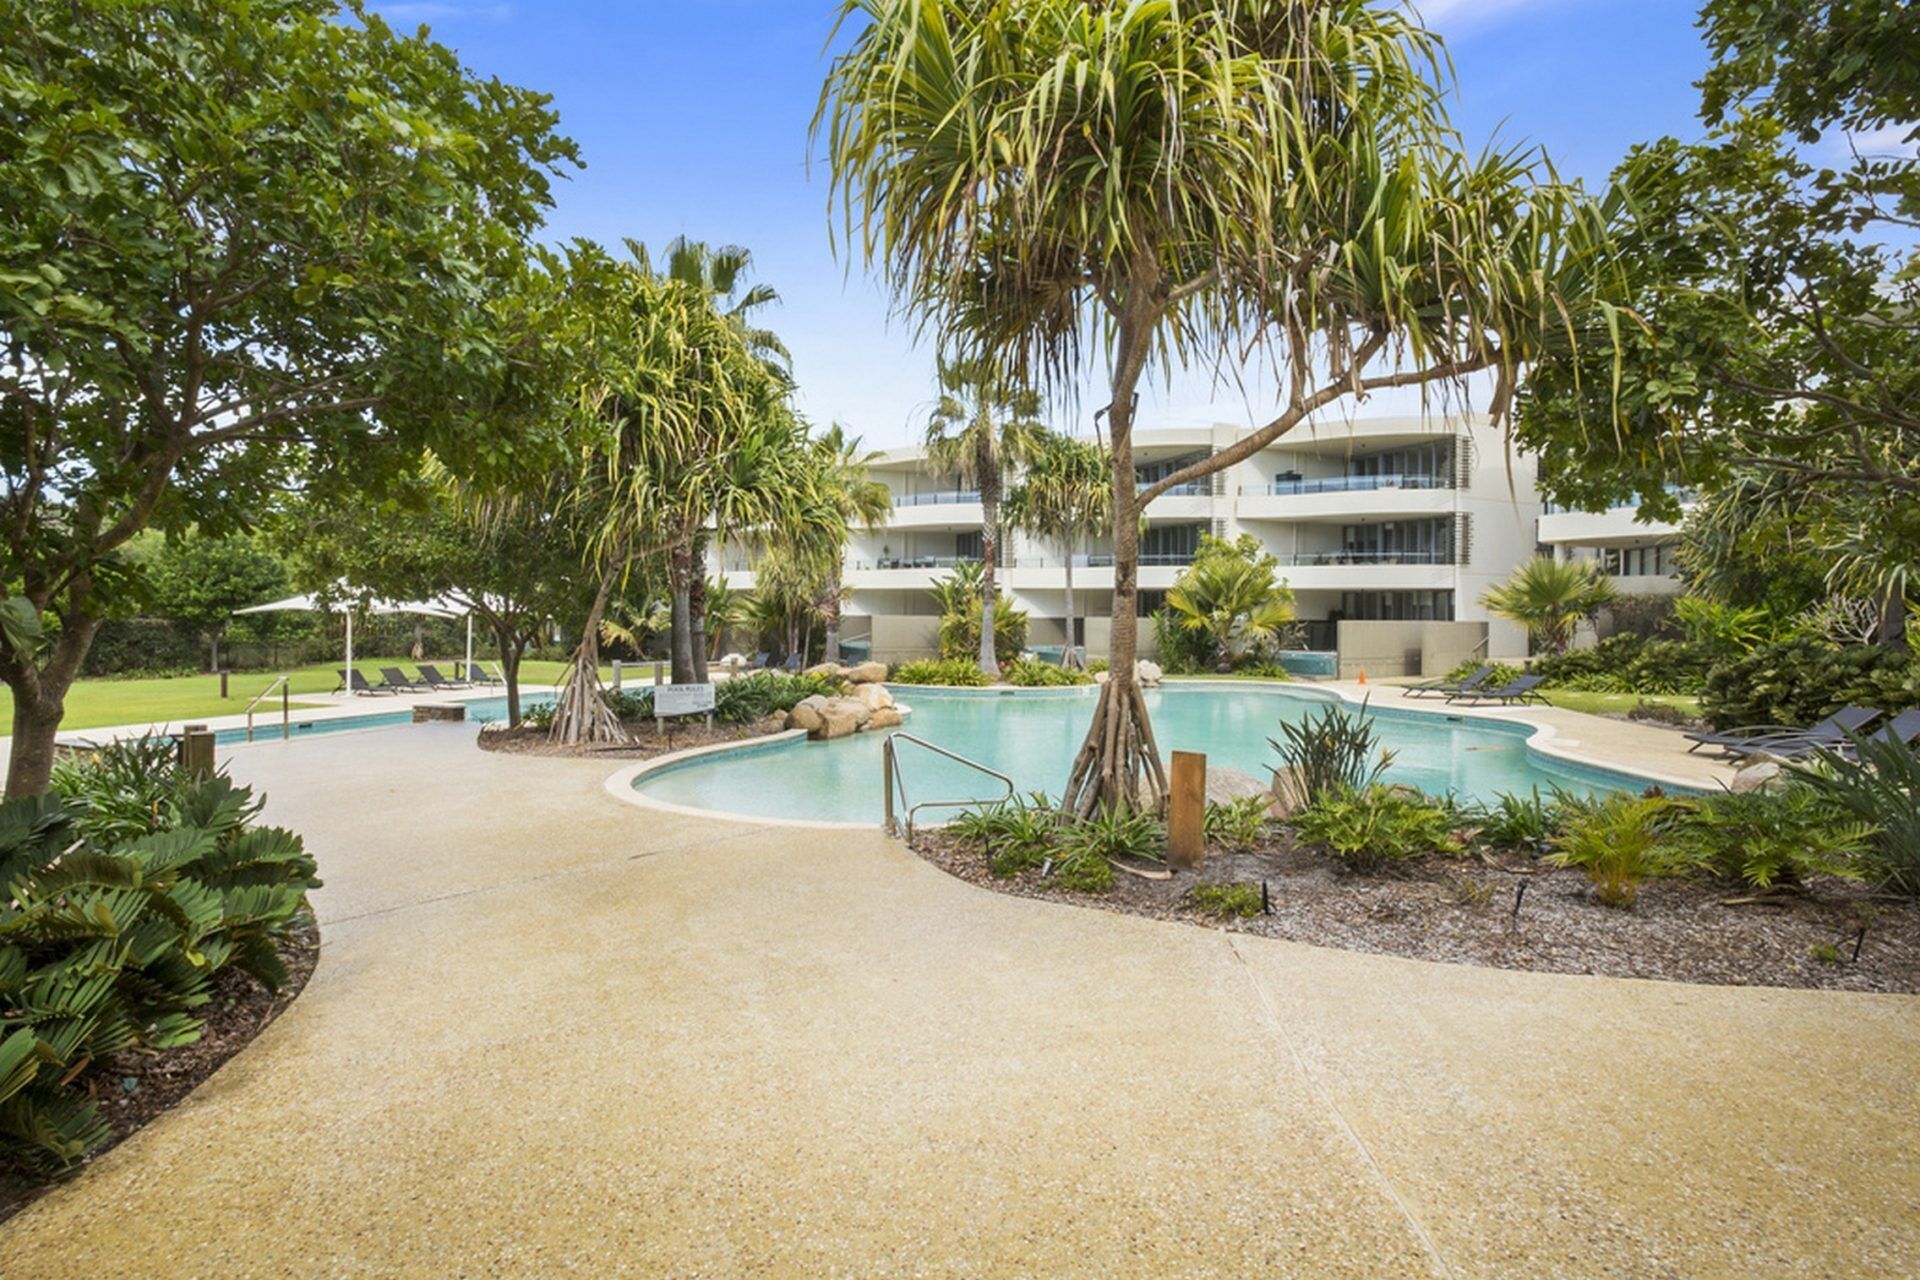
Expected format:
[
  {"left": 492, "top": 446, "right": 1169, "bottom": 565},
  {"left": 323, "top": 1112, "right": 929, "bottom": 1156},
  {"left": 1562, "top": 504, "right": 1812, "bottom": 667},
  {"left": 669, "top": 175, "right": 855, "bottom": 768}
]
[{"left": 722, "top": 415, "right": 1689, "bottom": 676}]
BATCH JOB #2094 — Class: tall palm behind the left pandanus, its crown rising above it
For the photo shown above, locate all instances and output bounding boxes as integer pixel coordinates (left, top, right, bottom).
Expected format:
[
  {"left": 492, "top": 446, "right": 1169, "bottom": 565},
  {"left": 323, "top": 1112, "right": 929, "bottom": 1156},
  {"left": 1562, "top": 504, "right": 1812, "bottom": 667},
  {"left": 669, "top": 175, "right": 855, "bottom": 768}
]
[{"left": 628, "top": 236, "right": 791, "bottom": 681}]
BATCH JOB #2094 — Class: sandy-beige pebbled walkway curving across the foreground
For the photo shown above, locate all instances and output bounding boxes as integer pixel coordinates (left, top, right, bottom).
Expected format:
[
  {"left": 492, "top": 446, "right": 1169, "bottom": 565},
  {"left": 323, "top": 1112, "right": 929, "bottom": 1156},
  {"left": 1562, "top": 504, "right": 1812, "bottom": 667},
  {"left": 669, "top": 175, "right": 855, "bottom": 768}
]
[{"left": 0, "top": 725, "right": 1920, "bottom": 1280}]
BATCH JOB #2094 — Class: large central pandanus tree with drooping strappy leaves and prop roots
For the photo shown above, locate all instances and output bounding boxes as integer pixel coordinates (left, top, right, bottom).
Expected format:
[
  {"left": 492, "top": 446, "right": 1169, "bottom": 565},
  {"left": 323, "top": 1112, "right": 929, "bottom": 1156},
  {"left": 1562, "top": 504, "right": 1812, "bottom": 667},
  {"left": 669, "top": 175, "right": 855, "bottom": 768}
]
[{"left": 814, "top": 0, "right": 1605, "bottom": 814}]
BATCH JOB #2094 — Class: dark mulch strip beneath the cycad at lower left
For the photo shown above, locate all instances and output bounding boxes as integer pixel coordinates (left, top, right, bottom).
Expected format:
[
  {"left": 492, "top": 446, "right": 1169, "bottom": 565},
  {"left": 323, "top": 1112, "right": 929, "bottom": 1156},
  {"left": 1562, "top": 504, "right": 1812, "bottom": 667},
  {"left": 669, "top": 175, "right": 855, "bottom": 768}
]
[{"left": 0, "top": 919, "right": 321, "bottom": 1222}]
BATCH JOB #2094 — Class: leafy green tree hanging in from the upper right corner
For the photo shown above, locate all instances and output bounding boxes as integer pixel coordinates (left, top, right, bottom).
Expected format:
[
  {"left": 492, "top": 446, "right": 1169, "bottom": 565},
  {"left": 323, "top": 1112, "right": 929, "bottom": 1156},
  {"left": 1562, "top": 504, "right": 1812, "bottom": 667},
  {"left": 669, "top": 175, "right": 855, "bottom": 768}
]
[{"left": 1519, "top": 0, "right": 1920, "bottom": 647}]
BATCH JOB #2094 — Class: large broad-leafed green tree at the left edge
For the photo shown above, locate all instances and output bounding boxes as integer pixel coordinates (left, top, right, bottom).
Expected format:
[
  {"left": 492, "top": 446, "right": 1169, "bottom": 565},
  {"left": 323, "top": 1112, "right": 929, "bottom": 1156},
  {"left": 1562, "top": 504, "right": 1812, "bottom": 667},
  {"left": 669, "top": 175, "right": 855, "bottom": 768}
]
[{"left": 0, "top": 0, "right": 574, "bottom": 794}]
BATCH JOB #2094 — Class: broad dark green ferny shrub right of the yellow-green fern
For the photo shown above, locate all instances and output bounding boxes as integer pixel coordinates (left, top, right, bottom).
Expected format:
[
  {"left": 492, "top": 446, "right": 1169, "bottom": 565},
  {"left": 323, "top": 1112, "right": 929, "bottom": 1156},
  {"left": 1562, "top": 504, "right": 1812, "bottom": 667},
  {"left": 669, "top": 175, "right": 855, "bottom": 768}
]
[{"left": 1668, "top": 785, "right": 1876, "bottom": 889}]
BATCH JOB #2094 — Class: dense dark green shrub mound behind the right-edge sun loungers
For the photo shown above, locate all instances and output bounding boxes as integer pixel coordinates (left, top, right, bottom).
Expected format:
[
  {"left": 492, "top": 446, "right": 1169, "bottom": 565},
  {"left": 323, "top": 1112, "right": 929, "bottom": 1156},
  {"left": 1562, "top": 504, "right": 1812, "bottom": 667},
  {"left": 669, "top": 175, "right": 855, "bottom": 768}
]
[{"left": 1699, "top": 637, "right": 1920, "bottom": 727}]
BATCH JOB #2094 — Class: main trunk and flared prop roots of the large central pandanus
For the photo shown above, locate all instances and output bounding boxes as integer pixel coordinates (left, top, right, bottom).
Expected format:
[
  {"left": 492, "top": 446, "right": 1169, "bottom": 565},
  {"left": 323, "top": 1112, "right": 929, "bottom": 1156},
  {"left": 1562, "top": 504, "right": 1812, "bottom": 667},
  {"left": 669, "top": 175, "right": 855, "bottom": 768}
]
[{"left": 1060, "top": 293, "right": 1167, "bottom": 818}]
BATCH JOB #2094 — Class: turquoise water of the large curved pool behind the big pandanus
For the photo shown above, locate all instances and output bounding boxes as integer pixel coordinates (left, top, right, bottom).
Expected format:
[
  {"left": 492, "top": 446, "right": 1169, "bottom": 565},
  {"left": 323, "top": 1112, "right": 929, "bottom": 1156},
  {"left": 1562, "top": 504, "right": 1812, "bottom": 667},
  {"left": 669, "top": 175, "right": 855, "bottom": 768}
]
[{"left": 634, "top": 685, "right": 1666, "bottom": 823}]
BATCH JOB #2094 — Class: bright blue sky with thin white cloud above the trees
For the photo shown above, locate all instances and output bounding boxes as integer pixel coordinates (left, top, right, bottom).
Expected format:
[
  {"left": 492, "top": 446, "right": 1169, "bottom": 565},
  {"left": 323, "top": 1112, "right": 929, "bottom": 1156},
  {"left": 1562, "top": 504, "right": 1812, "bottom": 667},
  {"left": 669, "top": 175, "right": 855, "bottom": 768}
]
[{"left": 371, "top": 0, "right": 1707, "bottom": 445}]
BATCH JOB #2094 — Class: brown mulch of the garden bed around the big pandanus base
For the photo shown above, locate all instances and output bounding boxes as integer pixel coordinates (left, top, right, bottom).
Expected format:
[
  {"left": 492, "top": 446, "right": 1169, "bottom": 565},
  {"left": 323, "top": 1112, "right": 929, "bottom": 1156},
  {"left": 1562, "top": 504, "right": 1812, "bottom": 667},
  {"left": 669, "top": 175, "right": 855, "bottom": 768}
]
[{"left": 914, "top": 827, "right": 1920, "bottom": 992}]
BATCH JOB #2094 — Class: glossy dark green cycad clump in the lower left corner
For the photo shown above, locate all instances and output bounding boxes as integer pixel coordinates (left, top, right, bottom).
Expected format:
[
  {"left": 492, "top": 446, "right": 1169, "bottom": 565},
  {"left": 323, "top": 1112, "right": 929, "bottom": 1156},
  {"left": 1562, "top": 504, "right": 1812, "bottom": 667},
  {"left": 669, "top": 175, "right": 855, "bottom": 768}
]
[{"left": 0, "top": 743, "right": 321, "bottom": 1173}]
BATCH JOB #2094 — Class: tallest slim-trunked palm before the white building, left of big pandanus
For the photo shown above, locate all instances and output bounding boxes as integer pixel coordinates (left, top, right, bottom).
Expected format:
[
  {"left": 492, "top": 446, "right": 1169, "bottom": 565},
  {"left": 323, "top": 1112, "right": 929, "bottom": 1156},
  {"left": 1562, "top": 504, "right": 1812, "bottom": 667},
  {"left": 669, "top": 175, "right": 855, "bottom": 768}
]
[{"left": 927, "top": 359, "right": 1046, "bottom": 679}]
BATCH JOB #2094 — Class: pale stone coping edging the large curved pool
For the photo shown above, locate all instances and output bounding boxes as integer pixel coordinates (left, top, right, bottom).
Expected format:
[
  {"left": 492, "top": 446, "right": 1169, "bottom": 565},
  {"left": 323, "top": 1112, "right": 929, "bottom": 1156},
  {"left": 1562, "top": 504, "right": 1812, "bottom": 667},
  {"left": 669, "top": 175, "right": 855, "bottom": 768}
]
[{"left": 601, "top": 677, "right": 1705, "bottom": 831}]
